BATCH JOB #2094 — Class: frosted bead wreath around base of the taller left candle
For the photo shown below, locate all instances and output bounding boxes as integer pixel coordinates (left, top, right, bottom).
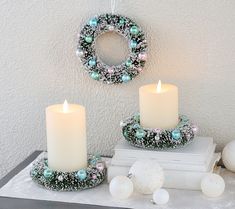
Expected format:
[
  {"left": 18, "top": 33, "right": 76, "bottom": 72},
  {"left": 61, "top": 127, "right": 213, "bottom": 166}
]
[{"left": 30, "top": 156, "right": 107, "bottom": 191}]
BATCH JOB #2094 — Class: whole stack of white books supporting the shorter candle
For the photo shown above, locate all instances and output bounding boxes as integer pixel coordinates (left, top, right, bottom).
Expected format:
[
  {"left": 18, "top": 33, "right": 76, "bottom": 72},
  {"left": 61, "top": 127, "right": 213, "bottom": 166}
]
[{"left": 108, "top": 137, "right": 221, "bottom": 190}]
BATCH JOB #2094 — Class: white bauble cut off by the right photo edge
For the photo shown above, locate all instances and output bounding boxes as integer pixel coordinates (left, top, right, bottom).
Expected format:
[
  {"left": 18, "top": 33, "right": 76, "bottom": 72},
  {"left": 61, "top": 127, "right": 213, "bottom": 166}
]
[{"left": 222, "top": 140, "right": 235, "bottom": 172}]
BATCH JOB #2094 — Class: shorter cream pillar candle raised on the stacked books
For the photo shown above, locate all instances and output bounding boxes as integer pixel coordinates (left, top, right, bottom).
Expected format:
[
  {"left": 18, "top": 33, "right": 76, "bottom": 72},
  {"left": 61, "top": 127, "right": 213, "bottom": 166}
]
[{"left": 139, "top": 81, "right": 179, "bottom": 129}]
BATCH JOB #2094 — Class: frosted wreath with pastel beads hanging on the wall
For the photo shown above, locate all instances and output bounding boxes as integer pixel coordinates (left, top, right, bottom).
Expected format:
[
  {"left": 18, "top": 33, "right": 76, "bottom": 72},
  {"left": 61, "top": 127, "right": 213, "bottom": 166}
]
[{"left": 76, "top": 14, "right": 147, "bottom": 84}]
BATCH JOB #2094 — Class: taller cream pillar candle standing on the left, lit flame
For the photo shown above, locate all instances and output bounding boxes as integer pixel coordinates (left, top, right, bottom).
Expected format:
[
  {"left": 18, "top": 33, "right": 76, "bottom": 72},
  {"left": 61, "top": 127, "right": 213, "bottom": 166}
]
[{"left": 46, "top": 100, "right": 87, "bottom": 172}]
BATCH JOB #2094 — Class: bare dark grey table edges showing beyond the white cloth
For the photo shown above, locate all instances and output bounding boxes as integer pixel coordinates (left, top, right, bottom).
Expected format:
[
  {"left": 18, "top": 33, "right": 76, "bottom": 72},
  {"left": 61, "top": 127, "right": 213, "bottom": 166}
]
[{"left": 0, "top": 151, "right": 126, "bottom": 209}]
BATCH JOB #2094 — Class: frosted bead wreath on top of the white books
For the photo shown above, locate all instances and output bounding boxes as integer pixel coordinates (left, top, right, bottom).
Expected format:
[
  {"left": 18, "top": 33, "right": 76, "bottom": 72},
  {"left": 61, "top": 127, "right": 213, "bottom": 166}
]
[{"left": 120, "top": 114, "right": 198, "bottom": 150}]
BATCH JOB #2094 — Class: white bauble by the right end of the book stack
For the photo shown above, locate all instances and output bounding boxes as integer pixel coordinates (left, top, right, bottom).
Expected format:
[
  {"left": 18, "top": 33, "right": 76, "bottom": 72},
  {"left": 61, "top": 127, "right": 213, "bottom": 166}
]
[{"left": 201, "top": 173, "right": 225, "bottom": 197}]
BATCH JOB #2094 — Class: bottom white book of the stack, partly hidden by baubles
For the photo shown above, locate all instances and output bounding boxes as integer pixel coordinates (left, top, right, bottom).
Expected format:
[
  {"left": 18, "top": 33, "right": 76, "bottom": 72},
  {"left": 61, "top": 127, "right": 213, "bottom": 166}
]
[{"left": 108, "top": 153, "right": 221, "bottom": 190}]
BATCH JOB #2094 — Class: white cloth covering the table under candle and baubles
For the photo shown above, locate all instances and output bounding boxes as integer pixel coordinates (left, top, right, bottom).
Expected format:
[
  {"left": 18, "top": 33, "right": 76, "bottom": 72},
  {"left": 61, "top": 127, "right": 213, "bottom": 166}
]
[{"left": 0, "top": 152, "right": 235, "bottom": 209}]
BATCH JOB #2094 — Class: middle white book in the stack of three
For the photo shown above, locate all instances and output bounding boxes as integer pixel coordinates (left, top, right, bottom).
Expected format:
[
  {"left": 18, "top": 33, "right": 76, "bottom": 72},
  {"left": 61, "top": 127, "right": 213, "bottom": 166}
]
[{"left": 111, "top": 144, "right": 216, "bottom": 172}]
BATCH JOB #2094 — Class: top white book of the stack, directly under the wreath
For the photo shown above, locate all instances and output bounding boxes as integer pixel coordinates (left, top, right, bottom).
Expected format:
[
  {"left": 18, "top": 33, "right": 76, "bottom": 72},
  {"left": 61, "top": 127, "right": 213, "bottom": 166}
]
[{"left": 114, "top": 137, "right": 214, "bottom": 165}]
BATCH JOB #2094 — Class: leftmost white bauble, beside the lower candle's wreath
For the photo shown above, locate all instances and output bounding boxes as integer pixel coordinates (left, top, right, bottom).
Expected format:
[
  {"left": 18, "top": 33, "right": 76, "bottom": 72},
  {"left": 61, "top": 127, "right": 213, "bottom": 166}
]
[{"left": 109, "top": 176, "right": 133, "bottom": 199}]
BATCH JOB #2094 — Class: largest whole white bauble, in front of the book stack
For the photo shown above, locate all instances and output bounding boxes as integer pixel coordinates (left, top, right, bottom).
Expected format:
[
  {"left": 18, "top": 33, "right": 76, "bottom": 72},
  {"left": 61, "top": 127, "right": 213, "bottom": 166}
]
[{"left": 129, "top": 160, "right": 164, "bottom": 194}]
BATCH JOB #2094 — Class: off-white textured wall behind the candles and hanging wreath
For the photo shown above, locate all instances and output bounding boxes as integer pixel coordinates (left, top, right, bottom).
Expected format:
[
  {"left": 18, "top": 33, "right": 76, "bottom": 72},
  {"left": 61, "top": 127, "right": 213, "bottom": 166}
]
[{"left": 0, "top": 0, "right": 235, "bottom": 177}]
